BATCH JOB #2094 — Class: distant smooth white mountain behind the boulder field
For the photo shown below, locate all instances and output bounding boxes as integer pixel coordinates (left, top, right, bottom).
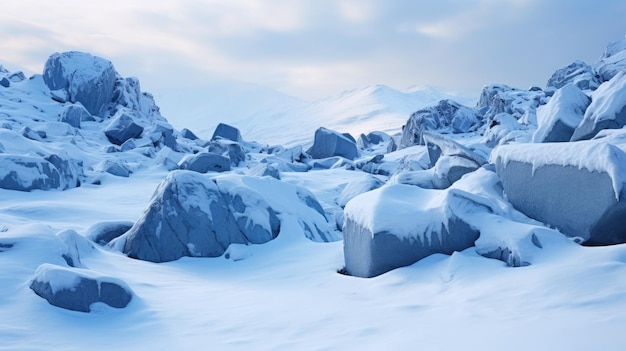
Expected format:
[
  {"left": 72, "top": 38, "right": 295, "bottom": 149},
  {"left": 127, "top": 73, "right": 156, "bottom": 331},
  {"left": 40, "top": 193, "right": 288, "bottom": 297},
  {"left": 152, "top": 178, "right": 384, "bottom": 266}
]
[{"left": 157, "top": 81, "right": 475, "bottom": 146}]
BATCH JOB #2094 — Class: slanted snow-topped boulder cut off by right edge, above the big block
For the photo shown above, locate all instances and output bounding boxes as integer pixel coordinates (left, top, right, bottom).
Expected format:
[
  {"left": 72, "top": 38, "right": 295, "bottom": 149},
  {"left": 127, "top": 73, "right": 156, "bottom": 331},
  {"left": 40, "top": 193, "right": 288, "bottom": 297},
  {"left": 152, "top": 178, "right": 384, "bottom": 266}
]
[{"left": 571, "top": 71, "right": 626, "bottom": 141}]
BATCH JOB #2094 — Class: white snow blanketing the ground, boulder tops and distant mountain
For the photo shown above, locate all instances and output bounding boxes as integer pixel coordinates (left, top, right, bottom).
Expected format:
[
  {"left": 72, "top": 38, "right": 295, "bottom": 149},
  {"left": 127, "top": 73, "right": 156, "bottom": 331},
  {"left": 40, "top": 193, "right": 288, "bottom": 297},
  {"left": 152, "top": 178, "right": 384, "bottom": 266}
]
[{"left": 0, "top": 47, "right": 626, "bottom": 350}]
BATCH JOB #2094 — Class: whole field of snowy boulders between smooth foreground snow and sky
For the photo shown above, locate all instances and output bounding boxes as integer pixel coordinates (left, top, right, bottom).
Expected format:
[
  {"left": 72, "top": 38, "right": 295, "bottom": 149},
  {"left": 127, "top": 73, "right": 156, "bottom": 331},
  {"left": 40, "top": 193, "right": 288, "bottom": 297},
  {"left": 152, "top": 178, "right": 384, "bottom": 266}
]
[{"left": 0, "top": 37, "right": 626, "bottom": 312}]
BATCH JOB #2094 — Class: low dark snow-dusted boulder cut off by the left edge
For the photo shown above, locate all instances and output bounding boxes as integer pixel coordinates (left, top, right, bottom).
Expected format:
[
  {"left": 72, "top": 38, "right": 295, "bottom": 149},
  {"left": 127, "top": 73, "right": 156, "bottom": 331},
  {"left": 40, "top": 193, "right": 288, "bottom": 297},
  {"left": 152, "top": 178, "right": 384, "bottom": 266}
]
[{"left": 0, "top": 154, "right": 62, "bottom": 191}]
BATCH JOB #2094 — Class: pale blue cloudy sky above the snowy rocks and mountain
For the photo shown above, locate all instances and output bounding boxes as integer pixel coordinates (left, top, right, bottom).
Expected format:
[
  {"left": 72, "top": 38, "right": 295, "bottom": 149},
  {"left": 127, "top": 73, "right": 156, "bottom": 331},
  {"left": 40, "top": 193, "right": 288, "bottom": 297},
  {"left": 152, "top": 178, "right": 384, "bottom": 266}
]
[{"left": 0, "top": 0, "right": 626, "bottom": 100}]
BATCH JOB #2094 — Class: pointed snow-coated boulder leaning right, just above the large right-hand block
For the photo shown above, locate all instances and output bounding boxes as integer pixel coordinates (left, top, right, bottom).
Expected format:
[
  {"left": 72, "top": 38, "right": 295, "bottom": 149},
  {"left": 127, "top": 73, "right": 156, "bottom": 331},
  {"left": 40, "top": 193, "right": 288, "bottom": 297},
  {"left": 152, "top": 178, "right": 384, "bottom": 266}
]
[{"left": 533, "top": 83, "right": 591, "bottom": 143}]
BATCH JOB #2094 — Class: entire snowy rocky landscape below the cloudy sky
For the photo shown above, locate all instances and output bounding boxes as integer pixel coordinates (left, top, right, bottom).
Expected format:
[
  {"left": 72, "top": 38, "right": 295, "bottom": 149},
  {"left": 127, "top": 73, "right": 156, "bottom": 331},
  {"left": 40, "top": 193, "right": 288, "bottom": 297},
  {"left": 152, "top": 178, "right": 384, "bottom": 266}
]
[{"left": 0, "top": 41, "right": 626, "bottom": 350}]
